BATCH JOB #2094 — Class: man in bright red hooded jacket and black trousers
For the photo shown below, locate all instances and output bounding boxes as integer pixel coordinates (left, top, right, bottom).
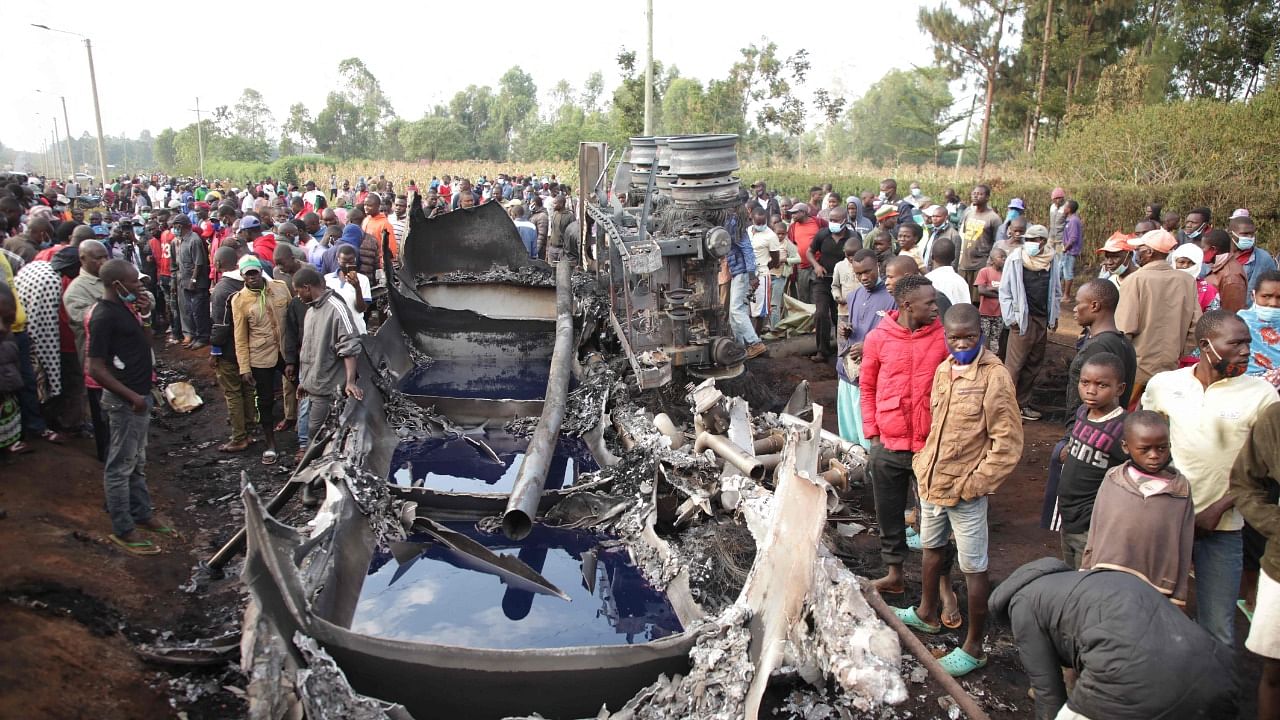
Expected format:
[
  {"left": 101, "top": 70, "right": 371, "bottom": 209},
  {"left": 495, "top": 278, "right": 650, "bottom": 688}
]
[{"left": 859, "top": 275, "right": 947, "bottom": 593}]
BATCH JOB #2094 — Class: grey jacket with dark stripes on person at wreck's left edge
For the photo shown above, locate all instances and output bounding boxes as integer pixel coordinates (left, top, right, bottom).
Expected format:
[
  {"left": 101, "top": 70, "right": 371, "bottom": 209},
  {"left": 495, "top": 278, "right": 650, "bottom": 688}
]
[{"left": 298, "top": 290, "right": 361, "bottom": 397}]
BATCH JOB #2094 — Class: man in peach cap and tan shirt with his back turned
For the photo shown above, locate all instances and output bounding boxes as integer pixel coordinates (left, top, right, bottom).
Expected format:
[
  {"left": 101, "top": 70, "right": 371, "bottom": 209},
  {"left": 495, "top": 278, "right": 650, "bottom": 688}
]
[{"left": 1116, "top": 229, "right": 1201, "bottom": 398}]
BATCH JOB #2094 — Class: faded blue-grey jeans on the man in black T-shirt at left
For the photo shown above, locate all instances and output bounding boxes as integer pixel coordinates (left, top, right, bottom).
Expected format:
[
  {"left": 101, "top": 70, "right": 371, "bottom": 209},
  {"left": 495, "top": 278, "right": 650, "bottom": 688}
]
[{"left": 102, "top": 391, "right": 152, "bottom": 537}]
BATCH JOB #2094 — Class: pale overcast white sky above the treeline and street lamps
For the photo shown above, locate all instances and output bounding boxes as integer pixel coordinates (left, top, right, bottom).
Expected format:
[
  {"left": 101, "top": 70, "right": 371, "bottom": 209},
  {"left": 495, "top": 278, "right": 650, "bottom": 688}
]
[{"left": 0, "top": 0, "right": 952, "bottom": 150}]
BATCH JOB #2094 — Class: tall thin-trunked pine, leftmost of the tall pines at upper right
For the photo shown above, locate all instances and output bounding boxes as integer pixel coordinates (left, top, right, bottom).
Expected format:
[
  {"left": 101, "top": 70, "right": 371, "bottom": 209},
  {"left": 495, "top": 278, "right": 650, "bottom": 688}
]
[{"left": 919, "top": 0, "right": 1016, "bottom": 174}]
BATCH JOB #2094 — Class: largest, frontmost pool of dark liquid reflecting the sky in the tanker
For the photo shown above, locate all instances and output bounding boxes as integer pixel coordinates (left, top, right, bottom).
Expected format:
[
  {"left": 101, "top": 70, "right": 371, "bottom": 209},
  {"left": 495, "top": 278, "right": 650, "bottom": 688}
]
[{"left": 351, "top": 523, "right": 682, "bottom": 650}]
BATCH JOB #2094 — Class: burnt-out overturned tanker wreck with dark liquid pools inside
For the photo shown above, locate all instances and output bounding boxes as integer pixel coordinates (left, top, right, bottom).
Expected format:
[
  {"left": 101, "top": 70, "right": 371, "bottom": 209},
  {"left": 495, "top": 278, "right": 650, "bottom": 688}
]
[{"left": 238, "top": 136, "right": 906, "bottom": 720}]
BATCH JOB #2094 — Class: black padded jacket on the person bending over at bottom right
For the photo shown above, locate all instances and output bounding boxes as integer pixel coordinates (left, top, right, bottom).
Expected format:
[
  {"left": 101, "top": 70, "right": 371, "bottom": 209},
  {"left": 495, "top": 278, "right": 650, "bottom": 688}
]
[{"left": 989, "top": 557, "right": 1236, "bottom": 720}]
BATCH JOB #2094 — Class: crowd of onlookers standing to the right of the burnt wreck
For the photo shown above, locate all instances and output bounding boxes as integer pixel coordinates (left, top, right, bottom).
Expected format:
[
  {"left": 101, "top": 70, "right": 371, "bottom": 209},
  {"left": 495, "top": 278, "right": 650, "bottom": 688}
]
[{"left": 742, "top": 178, "right": 1280, "bottom": 719}]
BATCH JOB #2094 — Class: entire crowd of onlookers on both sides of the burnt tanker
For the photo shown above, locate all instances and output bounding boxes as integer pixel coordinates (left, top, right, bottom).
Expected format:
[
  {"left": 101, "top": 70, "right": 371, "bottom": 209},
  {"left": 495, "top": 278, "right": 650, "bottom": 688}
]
[{"left": 0, "top": 169, "right": 1280, "bottom": 720}]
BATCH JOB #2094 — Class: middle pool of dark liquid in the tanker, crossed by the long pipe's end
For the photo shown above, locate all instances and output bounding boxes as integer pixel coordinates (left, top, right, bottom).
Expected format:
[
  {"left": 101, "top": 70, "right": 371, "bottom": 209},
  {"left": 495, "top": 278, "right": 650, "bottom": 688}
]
[{"left": 390, "top": 428, "right": 599, "bottom": 493}]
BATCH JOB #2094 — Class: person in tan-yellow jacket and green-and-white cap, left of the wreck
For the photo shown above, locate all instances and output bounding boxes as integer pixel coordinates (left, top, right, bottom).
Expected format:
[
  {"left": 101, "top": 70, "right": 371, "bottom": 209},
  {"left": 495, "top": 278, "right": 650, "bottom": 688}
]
[{"left": 232, "top": 255, "right": 292, "bottom": 465}]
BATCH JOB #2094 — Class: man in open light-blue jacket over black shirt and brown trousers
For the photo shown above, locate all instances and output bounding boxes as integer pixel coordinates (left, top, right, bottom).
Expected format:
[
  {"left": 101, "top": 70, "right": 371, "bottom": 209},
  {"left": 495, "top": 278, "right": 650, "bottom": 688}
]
[{"left": 998, "top": 225, "right": 1062, "bottom": 420}]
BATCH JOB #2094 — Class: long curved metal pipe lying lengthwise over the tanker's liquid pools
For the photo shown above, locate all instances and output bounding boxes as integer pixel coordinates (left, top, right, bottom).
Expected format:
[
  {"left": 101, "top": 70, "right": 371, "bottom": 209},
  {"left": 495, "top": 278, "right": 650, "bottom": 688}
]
[{"left": 502, "top": 260, "right": 573, "bottom": 539}]
